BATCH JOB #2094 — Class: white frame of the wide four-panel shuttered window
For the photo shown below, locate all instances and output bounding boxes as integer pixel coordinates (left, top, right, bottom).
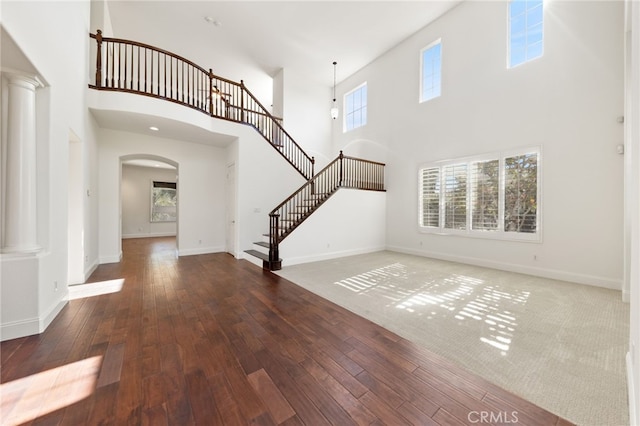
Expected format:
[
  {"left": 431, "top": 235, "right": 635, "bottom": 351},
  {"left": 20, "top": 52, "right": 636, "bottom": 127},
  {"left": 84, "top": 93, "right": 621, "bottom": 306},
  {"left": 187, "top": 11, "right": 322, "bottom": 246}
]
[{"left": 417, "top": 146, "right": 542, "bottom": 242}]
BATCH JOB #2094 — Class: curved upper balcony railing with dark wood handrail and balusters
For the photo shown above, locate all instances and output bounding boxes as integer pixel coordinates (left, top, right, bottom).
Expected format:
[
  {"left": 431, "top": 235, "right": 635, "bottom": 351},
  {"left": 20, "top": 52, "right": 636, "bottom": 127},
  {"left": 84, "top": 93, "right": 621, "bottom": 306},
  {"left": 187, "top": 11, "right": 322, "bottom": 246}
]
[{"left": 89, "top": 30, "right": 314, "bottom": 180}]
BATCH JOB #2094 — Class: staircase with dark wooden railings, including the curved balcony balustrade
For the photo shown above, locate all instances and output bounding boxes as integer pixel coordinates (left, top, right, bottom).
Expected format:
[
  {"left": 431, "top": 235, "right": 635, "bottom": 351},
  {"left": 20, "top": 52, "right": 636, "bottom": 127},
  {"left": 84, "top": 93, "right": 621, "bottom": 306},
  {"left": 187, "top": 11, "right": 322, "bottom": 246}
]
[{"left": 89, "top": 30, "right": 385, "bottom": 270}]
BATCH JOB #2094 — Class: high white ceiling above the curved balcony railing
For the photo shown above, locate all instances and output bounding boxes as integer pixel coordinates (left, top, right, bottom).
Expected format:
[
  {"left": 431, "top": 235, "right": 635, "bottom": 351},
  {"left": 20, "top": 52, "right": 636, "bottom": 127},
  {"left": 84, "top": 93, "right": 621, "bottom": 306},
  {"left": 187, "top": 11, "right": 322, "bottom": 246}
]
[{"left": 105, "top": 0, "right": 461, "bottom": 87}]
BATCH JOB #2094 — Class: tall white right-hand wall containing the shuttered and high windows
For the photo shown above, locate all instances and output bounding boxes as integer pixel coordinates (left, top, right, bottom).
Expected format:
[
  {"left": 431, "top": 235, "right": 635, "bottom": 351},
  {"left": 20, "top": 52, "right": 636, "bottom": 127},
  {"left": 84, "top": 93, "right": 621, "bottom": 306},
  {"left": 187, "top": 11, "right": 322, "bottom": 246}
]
[{"left": 334, "top": 1, "right": 624, "bottom": 289}]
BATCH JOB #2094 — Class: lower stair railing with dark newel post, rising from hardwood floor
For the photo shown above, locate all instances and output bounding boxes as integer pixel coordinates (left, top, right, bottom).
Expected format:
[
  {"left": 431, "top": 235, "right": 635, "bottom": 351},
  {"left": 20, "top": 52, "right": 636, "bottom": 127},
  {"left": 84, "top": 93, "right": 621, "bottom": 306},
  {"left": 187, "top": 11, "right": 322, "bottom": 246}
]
[{"left": 269, "top": 151, "right": 385, "bottom": 269}]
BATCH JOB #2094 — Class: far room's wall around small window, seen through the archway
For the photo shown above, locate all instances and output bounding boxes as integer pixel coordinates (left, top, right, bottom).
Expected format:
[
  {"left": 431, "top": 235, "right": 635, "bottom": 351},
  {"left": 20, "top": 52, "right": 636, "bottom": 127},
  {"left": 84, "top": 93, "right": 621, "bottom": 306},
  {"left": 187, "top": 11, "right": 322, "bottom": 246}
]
[{"left": 121, "top": 164, "right": 180, "bottom": 238}]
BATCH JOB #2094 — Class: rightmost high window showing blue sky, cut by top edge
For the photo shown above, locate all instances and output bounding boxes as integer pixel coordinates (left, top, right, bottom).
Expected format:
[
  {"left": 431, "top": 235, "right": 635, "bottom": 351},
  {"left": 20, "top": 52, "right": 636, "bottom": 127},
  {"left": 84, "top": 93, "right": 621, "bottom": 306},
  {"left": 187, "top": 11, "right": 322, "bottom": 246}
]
[{"left": 509, "top": 0, "right": 543, "bottom": 67}]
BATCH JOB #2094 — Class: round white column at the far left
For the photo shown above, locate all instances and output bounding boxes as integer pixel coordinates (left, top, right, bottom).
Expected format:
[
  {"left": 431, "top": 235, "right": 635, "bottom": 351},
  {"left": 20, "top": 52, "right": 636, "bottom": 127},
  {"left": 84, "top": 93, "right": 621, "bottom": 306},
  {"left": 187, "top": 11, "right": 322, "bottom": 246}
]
[{"left": 2, "top": 74, "right": 40, "bottom": 253}]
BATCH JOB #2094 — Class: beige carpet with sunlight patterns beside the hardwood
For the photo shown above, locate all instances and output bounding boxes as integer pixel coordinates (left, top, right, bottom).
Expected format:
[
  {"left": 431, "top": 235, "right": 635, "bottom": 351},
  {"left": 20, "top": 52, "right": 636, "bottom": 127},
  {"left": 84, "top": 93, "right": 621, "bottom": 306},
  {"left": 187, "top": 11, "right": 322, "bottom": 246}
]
[{"left": 278, "top": 252, "right": 629, "bottom": 426}]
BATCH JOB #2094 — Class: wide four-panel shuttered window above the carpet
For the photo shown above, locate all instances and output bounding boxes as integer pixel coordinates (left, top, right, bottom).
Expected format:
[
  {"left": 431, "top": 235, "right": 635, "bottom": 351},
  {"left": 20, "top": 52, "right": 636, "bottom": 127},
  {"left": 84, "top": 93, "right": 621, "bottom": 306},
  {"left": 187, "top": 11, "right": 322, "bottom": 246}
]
[{"left": 419, "top": 148, "right": 540, "bottom": 240}]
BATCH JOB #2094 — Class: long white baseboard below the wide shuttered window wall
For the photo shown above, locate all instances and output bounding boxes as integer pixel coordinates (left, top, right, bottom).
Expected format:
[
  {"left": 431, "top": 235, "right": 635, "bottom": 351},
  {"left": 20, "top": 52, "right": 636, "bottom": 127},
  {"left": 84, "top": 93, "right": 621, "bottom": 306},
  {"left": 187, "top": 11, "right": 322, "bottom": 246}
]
[{"left": 386, "top": 246, "right": 622, "bottom": 291}]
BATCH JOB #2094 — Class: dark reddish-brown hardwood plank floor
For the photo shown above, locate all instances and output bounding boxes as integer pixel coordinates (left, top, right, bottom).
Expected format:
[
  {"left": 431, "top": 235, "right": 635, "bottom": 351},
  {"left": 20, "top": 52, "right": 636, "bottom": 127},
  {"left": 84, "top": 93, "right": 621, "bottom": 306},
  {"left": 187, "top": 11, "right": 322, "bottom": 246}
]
[{"left": 0, "top": 238, "right": 570, "bottom": 426}]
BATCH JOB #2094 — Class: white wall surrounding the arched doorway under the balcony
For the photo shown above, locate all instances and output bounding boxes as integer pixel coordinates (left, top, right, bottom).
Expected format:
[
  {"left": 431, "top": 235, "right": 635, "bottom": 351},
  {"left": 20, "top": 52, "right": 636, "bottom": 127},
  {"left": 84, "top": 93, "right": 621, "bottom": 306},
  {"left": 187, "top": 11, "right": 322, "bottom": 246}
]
[{"left": 99, "top": 127, "right": 226, "bottom": 263}]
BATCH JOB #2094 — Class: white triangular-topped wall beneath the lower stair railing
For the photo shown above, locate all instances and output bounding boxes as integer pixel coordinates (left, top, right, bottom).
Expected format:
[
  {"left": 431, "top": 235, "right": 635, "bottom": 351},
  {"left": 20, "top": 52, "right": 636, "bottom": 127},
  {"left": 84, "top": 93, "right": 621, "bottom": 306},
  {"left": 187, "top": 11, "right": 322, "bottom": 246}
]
[{"left": 280, "top": 189, "right": 386, "bottom": 266}]
